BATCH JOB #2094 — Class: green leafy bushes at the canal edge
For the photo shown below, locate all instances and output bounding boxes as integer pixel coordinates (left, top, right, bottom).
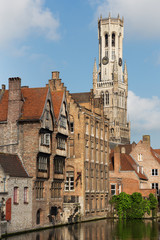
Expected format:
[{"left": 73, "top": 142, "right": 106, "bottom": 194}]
[{"left": 110, "top": 192, "right": 158, "bottom": 219}]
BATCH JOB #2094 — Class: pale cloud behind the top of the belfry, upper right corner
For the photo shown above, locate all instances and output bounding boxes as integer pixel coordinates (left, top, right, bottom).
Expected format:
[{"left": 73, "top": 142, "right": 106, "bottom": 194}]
[{"left": 92, "top": 0, "right": 160, "bottom": 39}]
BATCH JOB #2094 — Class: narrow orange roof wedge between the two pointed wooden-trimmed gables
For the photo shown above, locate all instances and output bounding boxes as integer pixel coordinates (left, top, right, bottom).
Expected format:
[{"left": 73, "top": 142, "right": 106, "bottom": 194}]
[{"left": 51, "top": 91, "right": 64, "bottom": 119}]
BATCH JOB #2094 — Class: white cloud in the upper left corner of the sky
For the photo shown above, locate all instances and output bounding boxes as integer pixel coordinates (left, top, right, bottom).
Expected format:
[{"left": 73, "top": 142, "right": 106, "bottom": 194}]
[{"left": 0, "top": 0, "right": 59, "bottom": 46}]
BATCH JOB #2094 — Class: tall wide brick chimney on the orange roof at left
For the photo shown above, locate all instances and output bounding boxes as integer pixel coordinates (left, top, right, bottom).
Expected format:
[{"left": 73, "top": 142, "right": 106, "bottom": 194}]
[{"left": 7, "top": 77, "right": 22, "bottom": 123}]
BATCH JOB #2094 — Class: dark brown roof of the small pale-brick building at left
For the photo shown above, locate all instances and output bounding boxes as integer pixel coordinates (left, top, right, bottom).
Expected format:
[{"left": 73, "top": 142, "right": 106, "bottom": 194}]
[{"left": 0, "top": 153, "right": 29, "bottom": 178}]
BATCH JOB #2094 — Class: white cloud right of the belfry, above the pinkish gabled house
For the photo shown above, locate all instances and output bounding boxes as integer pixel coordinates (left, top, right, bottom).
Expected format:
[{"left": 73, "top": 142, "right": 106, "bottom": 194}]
[{"left": 128, "top": 91, "right": 160, "bottom": 131}]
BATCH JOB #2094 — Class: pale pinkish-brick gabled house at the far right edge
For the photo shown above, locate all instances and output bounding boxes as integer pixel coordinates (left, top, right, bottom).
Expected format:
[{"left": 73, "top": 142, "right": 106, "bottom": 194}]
[{"left": 130, "top": 135, "right": 160, "bottom": 202}]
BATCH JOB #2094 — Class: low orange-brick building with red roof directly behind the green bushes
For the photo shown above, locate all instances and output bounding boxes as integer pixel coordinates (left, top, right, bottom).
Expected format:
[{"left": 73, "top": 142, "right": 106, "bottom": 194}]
[{"left": 109, "top": 144, "right": 155, "bottom": 197}]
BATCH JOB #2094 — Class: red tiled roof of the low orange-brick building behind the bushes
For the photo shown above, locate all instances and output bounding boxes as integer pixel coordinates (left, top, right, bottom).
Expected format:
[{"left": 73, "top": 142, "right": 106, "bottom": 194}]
[{"left": 109, "top": 151, "right": 147, "bottom": 180}]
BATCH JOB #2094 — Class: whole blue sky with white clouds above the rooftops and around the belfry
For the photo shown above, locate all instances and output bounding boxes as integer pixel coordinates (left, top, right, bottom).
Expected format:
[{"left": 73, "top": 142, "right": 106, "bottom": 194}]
[{"left": 0, "top": 0, "right": 160, "bottom": 148}]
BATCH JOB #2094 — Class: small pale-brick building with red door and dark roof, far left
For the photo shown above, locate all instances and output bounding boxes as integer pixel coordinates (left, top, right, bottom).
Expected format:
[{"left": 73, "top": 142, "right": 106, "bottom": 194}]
[{"left": 0, "top": 153, "right": 32, "bottom": 233}]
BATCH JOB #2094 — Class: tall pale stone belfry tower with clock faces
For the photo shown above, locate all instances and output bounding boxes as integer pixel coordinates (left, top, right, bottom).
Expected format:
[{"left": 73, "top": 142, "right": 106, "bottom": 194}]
[{"left": 93, "top": 15, "right": 130, "bottom": 143}]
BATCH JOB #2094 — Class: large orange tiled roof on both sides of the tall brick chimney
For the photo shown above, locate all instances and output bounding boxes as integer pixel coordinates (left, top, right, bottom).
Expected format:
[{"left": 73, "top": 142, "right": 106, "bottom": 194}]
[{"left": 0, "top": 87, "right": 48, "bottom": 121}]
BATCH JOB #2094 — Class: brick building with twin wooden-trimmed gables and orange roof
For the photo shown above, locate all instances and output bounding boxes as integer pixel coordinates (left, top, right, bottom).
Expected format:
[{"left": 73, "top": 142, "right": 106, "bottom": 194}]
[{"left": 0, "top": 78, "right": 68, "bottom": 227}]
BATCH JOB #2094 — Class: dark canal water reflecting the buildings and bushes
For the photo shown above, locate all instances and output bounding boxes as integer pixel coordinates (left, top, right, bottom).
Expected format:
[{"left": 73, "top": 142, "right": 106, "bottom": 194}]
[{"left": 5, "top": 220, "right": 160, "bottom": 240}]
